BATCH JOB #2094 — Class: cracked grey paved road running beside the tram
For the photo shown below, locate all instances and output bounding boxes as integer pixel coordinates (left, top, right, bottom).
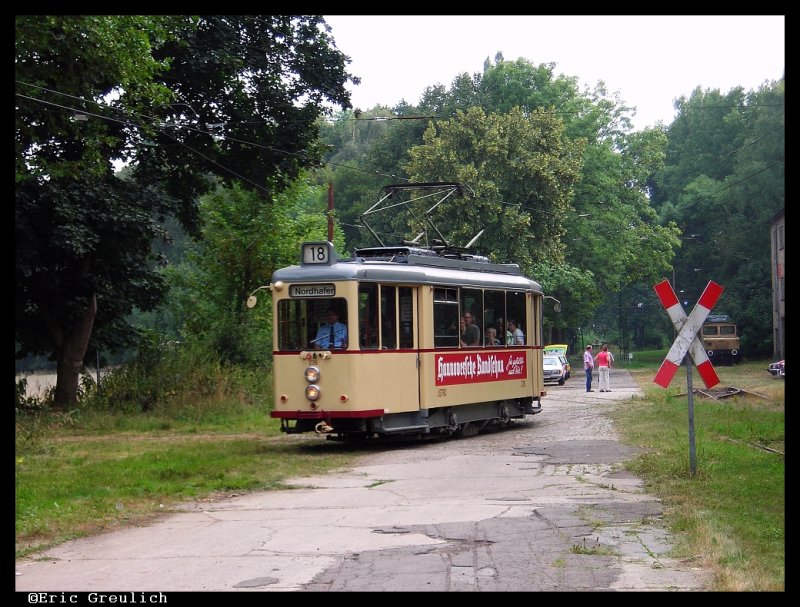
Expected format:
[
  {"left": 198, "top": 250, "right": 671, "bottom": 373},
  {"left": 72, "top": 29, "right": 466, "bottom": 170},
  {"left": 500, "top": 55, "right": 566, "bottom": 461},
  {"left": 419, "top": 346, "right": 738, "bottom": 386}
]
[{"left": 15, "top": 369, "right": 708, "bottom": 592}]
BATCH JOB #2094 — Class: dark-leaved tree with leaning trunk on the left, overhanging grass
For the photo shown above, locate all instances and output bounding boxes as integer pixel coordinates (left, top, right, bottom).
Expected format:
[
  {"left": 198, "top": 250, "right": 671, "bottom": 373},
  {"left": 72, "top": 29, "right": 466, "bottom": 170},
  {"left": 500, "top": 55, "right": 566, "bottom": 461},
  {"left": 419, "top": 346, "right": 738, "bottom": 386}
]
[{"left": 15, "top": 16, "right": 350, "bottom": 405}]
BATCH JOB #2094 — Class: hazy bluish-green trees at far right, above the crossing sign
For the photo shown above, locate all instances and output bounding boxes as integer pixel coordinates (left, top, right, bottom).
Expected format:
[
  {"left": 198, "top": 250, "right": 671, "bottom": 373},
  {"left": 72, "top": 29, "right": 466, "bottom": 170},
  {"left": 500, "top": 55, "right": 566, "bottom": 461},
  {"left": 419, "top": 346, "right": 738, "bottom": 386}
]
[{"left": 653, "top": 80, "right": 785, "bottom": 356}]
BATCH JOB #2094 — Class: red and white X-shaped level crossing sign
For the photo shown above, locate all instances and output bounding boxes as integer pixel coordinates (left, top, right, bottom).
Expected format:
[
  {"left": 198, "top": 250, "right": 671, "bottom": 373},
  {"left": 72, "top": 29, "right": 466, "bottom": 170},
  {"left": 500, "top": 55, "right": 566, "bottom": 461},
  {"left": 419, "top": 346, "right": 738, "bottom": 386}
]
[{"left": 653, "top": 280, "right": 724, "bottom": 388}]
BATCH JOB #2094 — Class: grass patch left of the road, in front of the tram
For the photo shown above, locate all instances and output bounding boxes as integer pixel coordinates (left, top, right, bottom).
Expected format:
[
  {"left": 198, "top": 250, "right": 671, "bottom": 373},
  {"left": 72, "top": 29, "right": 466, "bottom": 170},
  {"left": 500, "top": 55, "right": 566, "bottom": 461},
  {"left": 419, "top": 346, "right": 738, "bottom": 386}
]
[{"left": 16, "top": 404, "right": 351, "bottom": 557}]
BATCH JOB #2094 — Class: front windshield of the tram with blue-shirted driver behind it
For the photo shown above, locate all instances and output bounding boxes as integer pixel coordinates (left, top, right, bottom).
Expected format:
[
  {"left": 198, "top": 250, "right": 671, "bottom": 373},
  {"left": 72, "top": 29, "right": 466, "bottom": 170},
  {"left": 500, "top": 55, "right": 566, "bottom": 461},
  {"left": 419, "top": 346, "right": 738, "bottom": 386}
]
[{"left": 277, "top": 297, "right": 349, "bottom": 351}]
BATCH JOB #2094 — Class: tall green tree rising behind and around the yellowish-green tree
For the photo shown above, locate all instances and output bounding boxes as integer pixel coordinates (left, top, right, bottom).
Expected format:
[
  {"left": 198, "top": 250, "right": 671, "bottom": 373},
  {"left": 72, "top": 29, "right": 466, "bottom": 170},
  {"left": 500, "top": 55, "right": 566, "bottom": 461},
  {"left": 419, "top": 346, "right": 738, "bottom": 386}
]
[{"left": 320, "top": 53, "right": 679, "bottom": 339}]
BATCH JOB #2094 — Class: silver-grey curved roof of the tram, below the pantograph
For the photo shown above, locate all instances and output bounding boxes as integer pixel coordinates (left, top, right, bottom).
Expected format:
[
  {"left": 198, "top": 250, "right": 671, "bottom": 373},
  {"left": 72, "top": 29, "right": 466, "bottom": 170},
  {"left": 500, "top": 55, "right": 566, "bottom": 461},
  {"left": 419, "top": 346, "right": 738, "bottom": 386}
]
[{"left": 272, "top": 249, "right": 542, "bottom": 293}]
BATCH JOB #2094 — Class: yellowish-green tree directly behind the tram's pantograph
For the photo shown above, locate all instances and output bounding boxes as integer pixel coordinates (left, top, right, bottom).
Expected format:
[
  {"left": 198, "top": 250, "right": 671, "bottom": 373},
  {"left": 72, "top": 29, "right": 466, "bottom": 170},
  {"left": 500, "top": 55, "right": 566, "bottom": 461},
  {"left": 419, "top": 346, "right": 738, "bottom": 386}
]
[{"left": 408, "top": 108, "right": 582, "bottom": 272}]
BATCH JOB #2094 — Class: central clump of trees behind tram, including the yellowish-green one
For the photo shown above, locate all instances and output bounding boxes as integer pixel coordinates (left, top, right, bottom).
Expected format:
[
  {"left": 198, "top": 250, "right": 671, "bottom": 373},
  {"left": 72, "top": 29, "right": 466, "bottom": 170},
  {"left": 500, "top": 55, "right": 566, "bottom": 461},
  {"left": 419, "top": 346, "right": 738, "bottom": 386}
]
[{"left": 322, "top": 54, "right": 679, "bottom": 343}]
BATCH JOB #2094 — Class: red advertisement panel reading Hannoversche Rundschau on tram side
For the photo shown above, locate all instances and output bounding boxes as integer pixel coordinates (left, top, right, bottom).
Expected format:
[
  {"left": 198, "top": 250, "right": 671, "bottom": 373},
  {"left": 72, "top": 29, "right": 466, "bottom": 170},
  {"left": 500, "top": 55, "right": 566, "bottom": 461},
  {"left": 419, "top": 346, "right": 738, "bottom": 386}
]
[{"left": 434, "top": 350, "right": 528, "bottom": 386}]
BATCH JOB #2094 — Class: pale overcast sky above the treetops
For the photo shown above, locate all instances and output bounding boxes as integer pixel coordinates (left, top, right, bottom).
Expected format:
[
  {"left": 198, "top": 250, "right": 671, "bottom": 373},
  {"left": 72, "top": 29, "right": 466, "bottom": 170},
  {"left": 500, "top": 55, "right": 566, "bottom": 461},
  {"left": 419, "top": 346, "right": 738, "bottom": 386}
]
[{"left": 325, "top": 15, "right": 785, "bottom": 129}]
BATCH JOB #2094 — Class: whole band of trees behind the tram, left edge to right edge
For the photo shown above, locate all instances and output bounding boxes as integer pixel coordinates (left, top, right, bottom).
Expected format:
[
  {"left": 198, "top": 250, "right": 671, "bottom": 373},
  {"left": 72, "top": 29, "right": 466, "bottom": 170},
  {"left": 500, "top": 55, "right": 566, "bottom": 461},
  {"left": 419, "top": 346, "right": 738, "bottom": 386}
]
[{"left": 15, "top": 20, "right": 785, "bottom": 404}]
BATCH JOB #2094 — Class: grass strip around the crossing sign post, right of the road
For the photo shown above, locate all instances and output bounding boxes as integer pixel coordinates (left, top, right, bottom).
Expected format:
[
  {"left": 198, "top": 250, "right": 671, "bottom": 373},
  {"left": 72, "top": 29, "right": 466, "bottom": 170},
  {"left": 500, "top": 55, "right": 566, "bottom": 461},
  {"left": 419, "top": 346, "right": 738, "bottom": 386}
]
[{"left": 614, "top": 361, "right": 785, "bottom": 591}]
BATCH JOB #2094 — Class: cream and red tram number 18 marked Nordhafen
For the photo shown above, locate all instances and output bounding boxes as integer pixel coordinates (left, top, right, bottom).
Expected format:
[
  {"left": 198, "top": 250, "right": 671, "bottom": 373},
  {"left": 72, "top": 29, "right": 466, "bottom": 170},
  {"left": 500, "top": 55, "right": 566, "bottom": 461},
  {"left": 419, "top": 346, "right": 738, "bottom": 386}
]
[{"left": 270, "top": 242, "right": 545, "bottom": 439}]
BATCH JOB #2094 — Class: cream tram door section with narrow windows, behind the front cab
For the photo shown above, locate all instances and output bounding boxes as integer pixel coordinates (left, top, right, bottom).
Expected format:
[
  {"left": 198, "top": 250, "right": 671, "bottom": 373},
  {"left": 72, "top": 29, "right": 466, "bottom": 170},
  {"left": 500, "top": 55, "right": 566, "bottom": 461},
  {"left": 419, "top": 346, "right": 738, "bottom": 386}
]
[{"left": 357, "top": 283, "right": 419, "bottom": 413}]
